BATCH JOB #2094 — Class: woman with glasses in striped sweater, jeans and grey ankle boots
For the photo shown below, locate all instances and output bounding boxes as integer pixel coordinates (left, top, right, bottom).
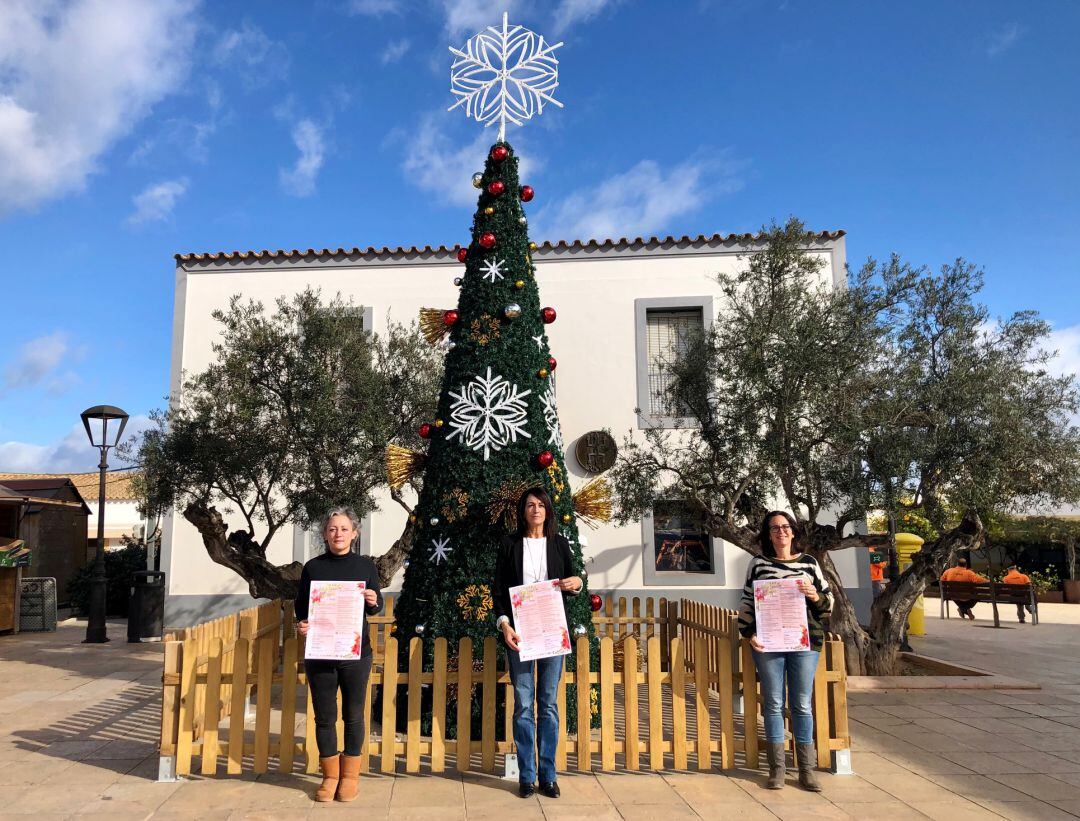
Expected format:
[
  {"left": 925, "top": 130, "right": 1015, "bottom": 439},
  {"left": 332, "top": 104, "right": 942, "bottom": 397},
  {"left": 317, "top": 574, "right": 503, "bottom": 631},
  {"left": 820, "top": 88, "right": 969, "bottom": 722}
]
[{"left": 739, "top": 510, "right": 833, "bottom": 792}]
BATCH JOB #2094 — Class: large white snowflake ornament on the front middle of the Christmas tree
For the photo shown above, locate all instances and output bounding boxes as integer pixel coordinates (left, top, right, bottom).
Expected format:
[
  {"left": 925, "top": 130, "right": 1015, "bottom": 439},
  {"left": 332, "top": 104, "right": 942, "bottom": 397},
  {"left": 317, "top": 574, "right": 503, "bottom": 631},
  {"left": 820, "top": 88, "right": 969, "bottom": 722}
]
[{"left": 446, "top": 365, "right": 532, "bottom": 461}]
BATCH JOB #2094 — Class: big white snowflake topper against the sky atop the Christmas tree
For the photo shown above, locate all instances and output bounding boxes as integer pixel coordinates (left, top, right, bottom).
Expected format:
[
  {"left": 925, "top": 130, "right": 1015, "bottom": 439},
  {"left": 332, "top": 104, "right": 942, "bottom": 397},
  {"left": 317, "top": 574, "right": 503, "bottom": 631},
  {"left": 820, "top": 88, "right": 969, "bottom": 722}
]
[{"left": 448, "top": 13, "right": 563, "bottom": 143}]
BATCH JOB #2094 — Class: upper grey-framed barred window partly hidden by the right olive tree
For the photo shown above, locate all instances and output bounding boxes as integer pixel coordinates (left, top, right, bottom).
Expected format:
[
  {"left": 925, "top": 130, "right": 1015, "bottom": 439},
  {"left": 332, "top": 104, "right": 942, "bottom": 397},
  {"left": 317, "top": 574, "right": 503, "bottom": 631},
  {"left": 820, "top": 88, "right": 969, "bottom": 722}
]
[{"left": 634, "top": 296, "right": 713, "bottom": 428}]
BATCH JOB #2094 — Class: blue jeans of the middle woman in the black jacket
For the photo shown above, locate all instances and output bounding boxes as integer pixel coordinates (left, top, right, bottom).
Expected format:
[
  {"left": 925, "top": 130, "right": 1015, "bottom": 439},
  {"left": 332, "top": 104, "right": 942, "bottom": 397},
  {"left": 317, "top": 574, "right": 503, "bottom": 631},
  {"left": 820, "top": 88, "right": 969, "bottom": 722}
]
[{"left": 507, "top": 648, "right": 565, "bottom": 784}]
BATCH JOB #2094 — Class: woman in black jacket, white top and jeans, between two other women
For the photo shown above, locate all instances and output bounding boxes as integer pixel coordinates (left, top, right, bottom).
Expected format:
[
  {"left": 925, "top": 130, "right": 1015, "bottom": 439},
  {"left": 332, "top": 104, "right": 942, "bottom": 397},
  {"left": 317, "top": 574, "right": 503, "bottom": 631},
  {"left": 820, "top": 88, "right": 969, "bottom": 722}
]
[{"left": 492, "top": 487, "right": 584, "bottom": 798}]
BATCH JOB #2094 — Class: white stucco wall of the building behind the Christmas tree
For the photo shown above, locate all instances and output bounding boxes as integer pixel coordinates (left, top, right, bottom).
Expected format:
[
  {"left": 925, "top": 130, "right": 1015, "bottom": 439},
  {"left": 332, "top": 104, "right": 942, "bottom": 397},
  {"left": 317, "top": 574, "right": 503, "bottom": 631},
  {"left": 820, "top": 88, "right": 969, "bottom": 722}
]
[{"left": 162, "top": 237, "right": 868, "bottom": 623}]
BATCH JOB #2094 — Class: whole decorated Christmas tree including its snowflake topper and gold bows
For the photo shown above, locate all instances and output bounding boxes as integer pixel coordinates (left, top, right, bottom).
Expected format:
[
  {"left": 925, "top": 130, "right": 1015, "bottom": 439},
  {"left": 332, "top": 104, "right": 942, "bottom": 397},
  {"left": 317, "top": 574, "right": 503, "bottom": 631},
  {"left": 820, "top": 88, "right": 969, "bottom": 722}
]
[{"left": 389, "top": 12, "right": 610, "bottom": 726}]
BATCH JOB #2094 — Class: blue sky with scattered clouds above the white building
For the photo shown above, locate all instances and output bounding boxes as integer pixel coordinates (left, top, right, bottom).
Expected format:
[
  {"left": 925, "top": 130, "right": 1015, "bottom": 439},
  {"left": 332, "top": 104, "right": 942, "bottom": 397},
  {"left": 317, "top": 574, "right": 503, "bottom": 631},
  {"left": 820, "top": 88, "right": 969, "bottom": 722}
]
[{"left": 0, "top": 0, "right": 1080, "bottom": 471}]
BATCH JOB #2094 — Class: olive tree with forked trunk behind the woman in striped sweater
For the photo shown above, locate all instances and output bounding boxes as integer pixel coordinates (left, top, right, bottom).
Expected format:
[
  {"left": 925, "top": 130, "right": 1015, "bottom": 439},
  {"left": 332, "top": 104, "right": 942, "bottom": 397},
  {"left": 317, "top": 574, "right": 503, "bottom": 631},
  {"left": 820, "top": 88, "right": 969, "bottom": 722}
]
[{"left": 611, "top": 219, "right": 1080, "bottom": 674}]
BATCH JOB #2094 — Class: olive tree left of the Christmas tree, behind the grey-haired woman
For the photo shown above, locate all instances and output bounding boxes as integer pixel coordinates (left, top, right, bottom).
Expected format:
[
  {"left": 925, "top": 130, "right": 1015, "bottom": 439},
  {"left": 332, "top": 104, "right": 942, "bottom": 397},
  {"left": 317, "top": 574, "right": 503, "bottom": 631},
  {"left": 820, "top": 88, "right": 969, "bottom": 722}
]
[{"left": 134, "top": 290, "right": 442, "bottom": 598}]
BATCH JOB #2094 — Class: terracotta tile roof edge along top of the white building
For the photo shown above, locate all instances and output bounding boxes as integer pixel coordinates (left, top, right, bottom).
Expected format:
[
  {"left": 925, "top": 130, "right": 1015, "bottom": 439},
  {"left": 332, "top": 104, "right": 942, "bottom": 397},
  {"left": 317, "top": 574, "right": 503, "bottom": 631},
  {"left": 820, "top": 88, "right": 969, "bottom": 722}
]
[{"left": 174, "top": 231, "right": 846, "bottom": 263}]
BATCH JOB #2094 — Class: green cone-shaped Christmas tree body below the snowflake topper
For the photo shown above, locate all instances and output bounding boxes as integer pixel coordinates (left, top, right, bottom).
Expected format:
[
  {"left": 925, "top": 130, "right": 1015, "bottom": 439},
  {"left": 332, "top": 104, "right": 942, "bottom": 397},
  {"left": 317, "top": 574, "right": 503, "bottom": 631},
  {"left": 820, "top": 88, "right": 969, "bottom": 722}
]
[{"left": 395, "top": 143, "right": 592, "bottom": 730}]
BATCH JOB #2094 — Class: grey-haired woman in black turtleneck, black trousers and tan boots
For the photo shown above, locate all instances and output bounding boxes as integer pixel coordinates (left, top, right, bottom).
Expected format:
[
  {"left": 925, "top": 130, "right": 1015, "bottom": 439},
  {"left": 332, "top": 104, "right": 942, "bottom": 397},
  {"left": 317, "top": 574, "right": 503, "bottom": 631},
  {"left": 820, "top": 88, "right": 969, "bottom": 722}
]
[{"left": 296, "top": 508, "right": 382, "bottom": 802}]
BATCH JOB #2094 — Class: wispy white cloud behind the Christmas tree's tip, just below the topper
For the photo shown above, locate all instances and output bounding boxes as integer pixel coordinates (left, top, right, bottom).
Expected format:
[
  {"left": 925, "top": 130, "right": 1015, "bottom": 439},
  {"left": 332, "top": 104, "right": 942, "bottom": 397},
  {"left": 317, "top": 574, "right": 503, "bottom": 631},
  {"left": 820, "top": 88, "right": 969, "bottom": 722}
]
[{"left": 402, "top": 112, "right": 538, "bottom": 206}]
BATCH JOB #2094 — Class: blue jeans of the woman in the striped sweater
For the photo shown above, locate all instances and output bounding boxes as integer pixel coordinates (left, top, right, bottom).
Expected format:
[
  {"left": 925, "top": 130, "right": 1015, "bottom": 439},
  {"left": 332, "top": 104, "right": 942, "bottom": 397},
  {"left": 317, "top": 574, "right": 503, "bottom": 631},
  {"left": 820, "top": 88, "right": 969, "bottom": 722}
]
[{"left": 754, "top": 650, "right": 819, "bottom": 744}]
